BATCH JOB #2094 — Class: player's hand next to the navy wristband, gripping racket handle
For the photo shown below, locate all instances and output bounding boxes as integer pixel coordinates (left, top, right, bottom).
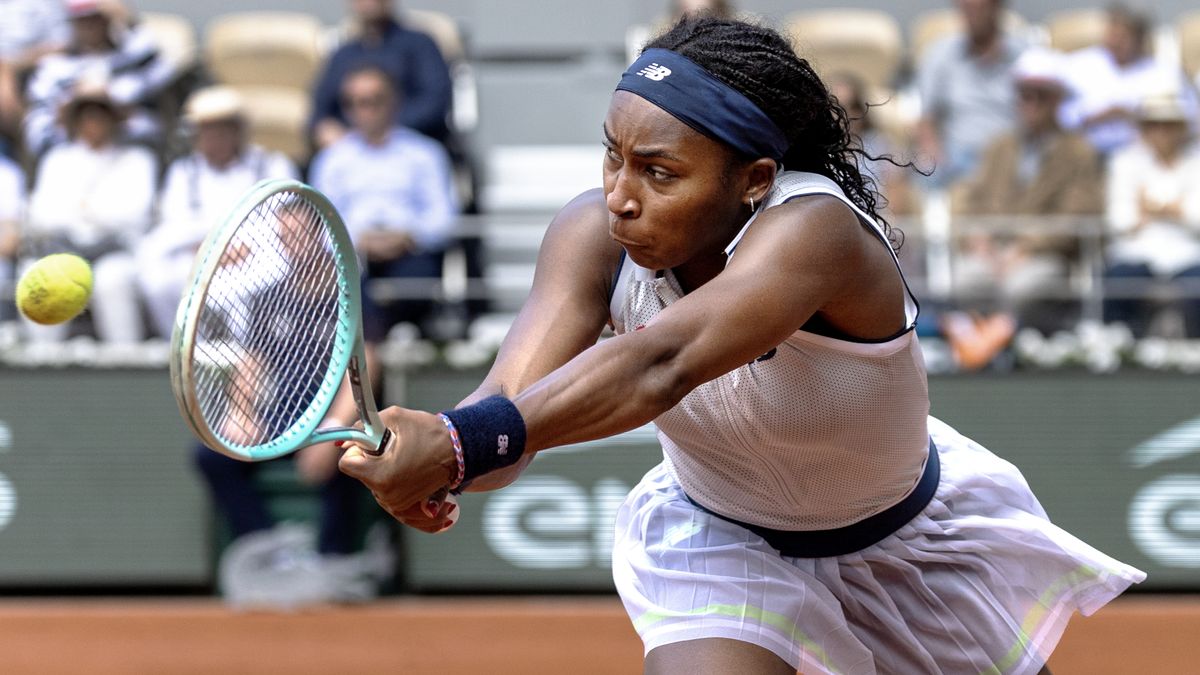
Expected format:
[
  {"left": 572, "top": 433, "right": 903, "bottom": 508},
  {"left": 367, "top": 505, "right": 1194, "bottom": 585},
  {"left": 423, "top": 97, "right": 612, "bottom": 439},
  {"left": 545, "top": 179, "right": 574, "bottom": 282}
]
[{"left": 337, "top": 406, "right": 458, "bottom": 524}]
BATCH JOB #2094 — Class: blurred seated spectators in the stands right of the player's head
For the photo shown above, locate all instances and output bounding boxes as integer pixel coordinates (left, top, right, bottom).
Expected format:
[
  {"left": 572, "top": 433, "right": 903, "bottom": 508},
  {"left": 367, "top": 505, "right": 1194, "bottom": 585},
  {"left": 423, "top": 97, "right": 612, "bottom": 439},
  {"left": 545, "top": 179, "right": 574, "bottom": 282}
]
[{"left": 657, "top": 0, "right": 1200, "bottom": 370}]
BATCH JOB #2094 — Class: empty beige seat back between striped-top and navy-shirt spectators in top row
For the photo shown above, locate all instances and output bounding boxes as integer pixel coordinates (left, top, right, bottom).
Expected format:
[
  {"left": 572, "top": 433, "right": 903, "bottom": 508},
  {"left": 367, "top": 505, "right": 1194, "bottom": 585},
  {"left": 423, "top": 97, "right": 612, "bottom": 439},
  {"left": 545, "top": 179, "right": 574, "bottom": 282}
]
[{"left": 204, "top": 12, "right": 324, "bottom": 89}]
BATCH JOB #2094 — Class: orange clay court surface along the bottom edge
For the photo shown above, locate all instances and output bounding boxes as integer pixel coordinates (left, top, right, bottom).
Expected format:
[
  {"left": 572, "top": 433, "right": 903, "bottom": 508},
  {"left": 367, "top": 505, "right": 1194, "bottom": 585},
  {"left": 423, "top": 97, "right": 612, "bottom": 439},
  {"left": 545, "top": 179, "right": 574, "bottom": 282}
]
[{"left": 0, "top": 596, "right": 1200, "bottom": 675}]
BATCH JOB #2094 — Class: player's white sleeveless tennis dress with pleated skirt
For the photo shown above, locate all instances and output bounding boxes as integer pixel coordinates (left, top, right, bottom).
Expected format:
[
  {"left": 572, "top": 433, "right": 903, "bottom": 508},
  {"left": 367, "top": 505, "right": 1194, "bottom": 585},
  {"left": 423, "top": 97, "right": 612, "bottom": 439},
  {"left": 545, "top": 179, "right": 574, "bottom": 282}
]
[{"left": 611, "top": 172, "right": 1145, "bottom": 675}]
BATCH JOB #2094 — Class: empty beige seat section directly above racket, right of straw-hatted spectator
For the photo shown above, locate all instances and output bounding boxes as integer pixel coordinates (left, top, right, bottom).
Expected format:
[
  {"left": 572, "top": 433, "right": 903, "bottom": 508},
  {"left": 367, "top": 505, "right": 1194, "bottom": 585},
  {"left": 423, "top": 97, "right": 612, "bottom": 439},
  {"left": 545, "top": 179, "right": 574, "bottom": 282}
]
[{"left": 229, "top": 85, "right": 312, "bottom": 166}]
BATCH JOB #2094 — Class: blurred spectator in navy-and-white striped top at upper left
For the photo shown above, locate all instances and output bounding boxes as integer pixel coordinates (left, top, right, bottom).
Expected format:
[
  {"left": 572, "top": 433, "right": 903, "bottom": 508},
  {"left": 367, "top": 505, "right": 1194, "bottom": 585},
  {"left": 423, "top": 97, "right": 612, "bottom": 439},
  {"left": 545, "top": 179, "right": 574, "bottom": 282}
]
[{"left": 24, "top": 0, "right": 175, "bottom": 156}]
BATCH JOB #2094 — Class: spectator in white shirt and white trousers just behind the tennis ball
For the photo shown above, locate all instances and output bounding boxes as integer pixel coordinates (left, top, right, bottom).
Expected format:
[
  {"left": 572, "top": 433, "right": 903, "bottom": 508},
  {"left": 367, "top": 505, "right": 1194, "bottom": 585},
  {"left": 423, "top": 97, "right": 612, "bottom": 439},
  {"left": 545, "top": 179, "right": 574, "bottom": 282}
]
[{"left": 22, "top": 83, "right": 158, "bottom": 342}]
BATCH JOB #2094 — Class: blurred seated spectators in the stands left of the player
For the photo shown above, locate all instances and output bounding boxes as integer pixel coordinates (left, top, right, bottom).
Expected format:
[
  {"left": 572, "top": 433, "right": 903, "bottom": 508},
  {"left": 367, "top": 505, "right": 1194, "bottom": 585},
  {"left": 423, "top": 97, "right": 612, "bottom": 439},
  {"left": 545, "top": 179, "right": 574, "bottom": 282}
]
[{"left": 0, "top": 0, "right": 473, "bottom": 344}]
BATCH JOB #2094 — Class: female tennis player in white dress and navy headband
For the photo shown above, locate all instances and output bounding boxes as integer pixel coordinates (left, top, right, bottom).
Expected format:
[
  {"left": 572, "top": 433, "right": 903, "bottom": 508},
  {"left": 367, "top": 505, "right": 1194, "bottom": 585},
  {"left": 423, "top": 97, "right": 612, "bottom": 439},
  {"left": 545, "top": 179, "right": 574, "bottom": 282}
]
[{"left": 341, "top": 18, "right": 1145, "bottom": 675}]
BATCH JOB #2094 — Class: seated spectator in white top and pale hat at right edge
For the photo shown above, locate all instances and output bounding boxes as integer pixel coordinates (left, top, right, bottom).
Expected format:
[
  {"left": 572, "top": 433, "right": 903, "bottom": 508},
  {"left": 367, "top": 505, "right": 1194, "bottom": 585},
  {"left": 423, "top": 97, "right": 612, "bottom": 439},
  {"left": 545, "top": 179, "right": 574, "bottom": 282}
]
[{"left": 1104, "top": 86, "right": 1200, "bottom": 338}]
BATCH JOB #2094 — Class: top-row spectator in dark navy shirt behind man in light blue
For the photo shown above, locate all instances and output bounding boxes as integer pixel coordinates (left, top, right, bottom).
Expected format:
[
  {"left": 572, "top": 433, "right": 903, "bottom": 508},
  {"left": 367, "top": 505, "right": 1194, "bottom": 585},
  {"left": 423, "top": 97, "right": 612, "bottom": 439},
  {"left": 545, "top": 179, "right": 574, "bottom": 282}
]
[{"left": 310, "top": 0, "right": 451, "bottom": 149}]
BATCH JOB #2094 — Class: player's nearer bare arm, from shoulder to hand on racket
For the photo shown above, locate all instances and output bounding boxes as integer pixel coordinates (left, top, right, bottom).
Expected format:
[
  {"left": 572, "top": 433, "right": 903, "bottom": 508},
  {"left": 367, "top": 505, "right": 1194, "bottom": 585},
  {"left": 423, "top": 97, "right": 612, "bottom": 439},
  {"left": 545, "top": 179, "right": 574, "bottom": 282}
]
[{"left": 342, "top": 197, "right": 904, "bottom": 509}]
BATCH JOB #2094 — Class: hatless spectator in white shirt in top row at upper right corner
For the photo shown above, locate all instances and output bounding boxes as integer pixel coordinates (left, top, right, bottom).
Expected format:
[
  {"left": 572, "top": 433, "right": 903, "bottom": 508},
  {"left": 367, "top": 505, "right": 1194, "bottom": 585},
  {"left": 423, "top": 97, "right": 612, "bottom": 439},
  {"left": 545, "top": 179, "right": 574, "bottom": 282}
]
[{"left": 1061, "top": 4, "right": 1196, "bottom": 156}]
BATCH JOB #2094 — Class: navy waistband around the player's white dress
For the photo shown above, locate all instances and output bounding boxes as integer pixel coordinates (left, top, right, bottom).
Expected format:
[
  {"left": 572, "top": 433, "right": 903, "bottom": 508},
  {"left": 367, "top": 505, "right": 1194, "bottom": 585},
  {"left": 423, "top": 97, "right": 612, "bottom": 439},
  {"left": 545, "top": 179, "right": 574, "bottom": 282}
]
[{"left": 684, "top": 438, "right": 941, "bottom": 557}]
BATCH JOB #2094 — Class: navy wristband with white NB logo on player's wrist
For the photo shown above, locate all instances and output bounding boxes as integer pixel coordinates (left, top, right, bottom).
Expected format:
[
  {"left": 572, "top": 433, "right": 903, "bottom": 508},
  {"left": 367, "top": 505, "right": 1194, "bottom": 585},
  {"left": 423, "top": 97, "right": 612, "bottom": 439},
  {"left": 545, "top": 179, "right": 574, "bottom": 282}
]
[{"left": 442, "top": 396, "right": 526, "bottom": 483}]
